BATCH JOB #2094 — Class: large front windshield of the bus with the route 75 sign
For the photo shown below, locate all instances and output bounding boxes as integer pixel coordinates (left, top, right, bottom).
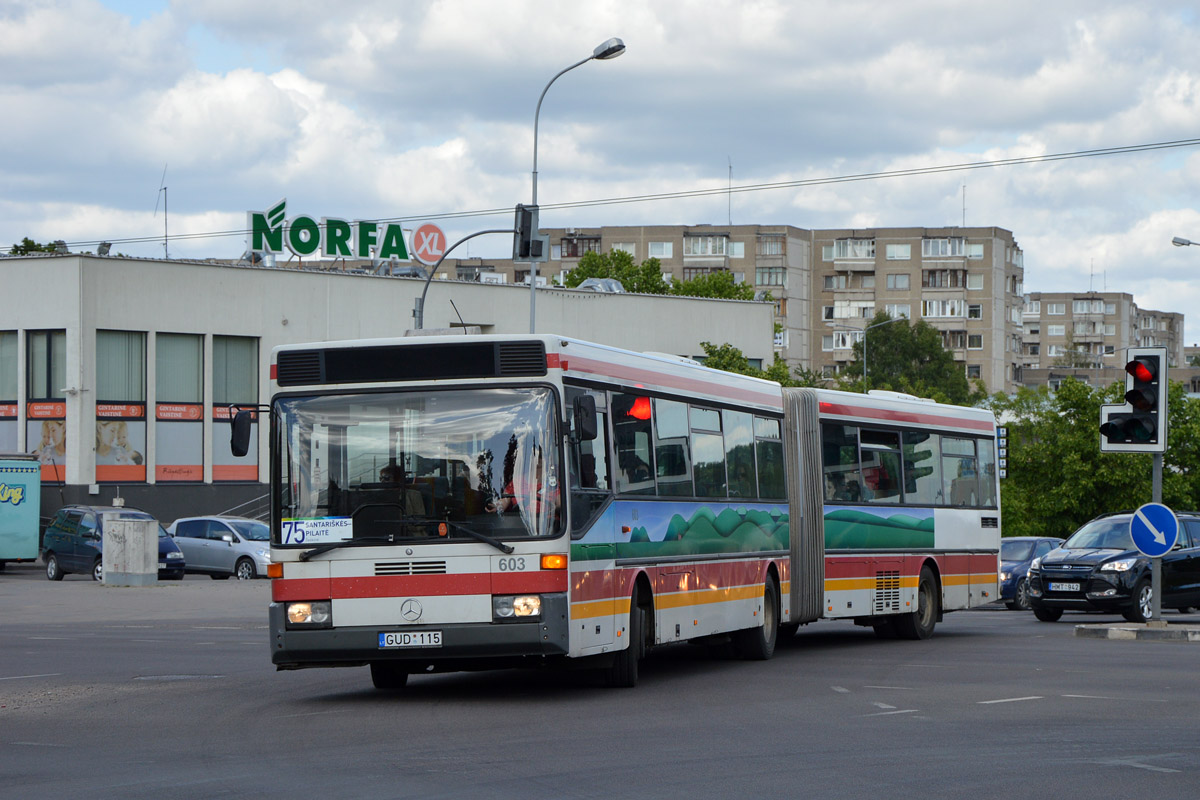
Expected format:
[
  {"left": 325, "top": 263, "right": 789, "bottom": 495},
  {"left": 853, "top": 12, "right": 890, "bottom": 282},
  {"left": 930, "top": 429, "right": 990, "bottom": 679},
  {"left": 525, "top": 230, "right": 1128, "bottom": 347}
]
[{"left": 275, "top": 387, "right": 563, "bottom": 545}]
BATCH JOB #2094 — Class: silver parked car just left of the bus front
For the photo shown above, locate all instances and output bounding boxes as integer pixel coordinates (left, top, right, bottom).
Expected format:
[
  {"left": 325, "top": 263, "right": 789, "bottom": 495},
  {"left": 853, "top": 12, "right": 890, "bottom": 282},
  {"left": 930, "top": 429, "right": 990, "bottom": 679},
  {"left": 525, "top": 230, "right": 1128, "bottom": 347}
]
[{"left": 167, "top": 516, "right": 271, "bottom": 581}]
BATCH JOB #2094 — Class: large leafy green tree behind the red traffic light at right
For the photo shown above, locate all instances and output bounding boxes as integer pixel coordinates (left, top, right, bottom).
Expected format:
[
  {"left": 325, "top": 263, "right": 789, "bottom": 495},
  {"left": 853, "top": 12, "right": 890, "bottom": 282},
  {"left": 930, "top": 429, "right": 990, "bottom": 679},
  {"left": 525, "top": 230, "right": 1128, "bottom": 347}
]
[{"left": 988, "top": 378, "right": 1200, "bottom": 536}]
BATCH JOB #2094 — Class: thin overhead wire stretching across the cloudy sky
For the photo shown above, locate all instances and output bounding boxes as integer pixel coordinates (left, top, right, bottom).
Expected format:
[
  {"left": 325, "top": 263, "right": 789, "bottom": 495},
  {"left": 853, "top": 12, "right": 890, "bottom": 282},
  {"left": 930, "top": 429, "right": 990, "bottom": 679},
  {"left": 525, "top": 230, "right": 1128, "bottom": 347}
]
[{"left": 8, "top": 138, "right": 1200, "bottom": 251}]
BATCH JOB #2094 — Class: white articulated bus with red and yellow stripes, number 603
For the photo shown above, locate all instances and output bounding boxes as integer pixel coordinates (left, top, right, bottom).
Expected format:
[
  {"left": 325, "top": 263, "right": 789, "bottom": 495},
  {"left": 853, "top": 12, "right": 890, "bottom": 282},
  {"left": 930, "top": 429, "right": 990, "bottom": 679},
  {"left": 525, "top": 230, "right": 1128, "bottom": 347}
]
[{"left": 232, "top": 335, "right": 1001, "bottom": 688}]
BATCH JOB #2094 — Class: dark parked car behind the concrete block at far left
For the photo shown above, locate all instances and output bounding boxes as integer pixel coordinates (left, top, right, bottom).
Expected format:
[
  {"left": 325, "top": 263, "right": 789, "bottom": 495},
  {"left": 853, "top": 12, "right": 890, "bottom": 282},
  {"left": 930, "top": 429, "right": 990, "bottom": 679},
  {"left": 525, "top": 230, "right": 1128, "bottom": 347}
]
[{"left": 41, "top": 505, "right": 185, "bottom": 581}]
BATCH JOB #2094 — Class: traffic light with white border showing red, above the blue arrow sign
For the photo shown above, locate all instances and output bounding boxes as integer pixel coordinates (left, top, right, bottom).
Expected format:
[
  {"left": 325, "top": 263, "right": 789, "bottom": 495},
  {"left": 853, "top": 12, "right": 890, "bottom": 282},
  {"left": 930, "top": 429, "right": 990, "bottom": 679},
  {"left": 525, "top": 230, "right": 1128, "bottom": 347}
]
[{"left": 1100, "top": 348, "right": 1168, "bottom": 452}]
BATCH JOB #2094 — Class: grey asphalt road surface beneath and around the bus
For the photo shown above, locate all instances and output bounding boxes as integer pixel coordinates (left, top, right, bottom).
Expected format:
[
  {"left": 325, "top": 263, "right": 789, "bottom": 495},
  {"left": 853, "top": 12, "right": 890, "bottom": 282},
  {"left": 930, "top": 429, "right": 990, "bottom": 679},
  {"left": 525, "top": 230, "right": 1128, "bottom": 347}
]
[{"left": 0, "top": 567, "right": 1200, "bottom": 800}]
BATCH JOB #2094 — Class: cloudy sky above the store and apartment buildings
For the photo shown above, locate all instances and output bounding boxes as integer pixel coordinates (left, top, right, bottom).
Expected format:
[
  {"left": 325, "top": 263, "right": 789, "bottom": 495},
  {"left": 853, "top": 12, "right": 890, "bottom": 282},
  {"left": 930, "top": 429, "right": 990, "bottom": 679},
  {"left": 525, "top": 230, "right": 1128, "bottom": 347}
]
[{"left": 0, "top": 0, "right": 1200, "bottom": 343}]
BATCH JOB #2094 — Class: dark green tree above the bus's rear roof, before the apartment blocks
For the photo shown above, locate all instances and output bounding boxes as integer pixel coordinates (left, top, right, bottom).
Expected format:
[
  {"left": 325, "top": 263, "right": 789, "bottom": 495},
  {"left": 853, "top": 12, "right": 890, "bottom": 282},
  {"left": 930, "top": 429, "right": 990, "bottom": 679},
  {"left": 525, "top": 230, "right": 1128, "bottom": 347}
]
[{"left": 839, "top": 312, "right": 986, "bottom": 404}]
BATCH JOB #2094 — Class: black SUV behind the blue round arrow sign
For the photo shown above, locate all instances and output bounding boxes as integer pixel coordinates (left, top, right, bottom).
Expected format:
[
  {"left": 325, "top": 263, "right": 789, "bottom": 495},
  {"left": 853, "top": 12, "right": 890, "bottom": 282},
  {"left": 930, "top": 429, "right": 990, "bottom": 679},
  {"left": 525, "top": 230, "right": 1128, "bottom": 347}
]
[{"left": 1028, "top": 511, "right": 1200, "bottom": 622}]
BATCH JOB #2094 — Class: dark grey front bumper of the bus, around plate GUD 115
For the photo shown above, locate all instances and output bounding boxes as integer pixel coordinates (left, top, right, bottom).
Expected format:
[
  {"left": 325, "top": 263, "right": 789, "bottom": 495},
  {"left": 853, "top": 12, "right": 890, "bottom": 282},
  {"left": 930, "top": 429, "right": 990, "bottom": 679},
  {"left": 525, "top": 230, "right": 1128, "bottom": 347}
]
[{"left": 270, "top": 593, "right": 568, "bottom": 672}]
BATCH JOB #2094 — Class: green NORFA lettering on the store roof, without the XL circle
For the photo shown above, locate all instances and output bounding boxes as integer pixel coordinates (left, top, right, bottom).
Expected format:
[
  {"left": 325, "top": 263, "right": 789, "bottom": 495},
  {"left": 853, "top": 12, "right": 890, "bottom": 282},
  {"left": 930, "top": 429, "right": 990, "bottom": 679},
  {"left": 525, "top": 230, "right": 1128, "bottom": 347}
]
[{"left": 246, "top": 198, "right": 409, "bottom": 261}]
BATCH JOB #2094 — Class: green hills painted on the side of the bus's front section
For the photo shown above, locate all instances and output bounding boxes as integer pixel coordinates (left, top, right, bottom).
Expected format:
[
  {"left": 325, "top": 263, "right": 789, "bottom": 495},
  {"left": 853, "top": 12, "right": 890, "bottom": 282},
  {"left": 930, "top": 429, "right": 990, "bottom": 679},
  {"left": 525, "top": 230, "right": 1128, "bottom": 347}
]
[{"left": 617, "top": 506, "right": 788, "bottom": 558}]
